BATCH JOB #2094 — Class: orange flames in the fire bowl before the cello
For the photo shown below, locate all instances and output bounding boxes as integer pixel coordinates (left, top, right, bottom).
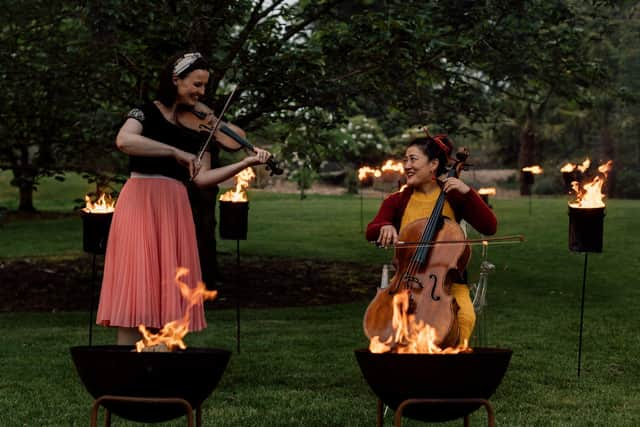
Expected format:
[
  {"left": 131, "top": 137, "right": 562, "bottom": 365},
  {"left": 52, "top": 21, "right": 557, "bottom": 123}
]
[{"left": 369, "top": 289, "right": 471, "bottom": 354}]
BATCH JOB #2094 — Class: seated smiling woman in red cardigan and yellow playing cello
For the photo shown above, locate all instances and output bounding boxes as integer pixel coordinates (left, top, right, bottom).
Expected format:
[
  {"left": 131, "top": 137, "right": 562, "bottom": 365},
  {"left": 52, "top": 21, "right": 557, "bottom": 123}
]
[{"left": 366, "top": 135, "right": 497, "bottom": 344}]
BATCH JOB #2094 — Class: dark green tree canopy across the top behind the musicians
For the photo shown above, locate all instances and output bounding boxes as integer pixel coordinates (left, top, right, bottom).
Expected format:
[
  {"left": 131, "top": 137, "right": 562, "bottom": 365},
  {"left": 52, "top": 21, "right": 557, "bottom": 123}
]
[{"left": 0, "top": 0, "right": 637, "bottom": 214}]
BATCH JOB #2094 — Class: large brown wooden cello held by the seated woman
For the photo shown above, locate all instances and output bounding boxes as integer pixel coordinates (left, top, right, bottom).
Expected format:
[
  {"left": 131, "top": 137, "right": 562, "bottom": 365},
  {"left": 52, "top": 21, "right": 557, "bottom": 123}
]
[{"left": 363, "top": 149, "right": 471, "bottom": 348}]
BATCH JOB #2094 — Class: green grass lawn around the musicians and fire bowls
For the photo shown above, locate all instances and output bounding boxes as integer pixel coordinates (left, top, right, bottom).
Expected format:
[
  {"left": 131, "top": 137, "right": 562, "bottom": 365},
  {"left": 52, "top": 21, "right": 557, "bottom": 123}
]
[{"left": 0, "top": 172, "right": 640, "bottom": 426}]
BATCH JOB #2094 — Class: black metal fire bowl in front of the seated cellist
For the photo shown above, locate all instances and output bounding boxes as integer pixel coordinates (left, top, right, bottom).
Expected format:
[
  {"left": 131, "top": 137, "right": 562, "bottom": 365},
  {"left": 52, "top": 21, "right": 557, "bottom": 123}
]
[{"left": 355, "top": 348, "right": 513, "bottom": 422}]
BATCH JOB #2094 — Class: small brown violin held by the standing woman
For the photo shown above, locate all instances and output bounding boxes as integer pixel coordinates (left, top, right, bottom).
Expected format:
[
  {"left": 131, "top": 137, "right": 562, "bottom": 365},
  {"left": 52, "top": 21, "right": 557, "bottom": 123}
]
[{"left": 176, "top": 102, "right": 284, "bottom": 176}]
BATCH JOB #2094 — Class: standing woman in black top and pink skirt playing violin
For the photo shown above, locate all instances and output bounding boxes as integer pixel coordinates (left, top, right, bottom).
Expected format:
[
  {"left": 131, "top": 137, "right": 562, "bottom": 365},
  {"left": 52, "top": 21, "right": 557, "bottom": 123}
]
[{"left": 97, "top": 52, "right": 270, "bottom": 344}]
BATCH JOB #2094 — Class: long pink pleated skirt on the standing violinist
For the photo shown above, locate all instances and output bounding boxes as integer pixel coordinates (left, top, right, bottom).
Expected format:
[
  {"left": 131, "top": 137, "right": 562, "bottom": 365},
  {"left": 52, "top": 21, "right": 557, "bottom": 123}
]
[{"left": 96, "top": 177, "right": 207, "bottom": 331}]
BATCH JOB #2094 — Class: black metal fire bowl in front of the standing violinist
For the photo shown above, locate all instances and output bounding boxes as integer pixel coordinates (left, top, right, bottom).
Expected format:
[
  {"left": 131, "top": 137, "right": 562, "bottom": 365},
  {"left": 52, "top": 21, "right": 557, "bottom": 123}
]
[{"left": 71, "top": 345, "right": 231, "bottom": 423}]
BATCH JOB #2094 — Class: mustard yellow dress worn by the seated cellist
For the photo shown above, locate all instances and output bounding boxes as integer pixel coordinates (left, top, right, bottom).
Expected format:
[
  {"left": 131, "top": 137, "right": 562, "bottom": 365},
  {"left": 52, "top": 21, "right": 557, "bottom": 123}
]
[{"left": 400, "top": 189, "right": 476, "bottom": 344}]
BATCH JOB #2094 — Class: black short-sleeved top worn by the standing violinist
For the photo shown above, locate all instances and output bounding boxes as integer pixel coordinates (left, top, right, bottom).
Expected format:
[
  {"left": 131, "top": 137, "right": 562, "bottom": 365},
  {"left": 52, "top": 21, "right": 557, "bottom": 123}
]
[{"left": 127, "top": 102, "right": 215, "bottom": 183}]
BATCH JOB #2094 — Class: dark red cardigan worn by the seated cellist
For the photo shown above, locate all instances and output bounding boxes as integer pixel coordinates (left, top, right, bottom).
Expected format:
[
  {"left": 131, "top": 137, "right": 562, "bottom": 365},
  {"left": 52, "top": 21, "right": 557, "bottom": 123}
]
[{"left": 366, "top": 186, "right": 498, "bottom": 241}]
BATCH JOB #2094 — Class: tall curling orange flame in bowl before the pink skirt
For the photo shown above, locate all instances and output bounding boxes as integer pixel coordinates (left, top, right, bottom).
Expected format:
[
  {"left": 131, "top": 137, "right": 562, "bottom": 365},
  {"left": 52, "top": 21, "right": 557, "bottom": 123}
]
[{"left": 136, "top": 267, "right": 218, "bottom": 353}]
